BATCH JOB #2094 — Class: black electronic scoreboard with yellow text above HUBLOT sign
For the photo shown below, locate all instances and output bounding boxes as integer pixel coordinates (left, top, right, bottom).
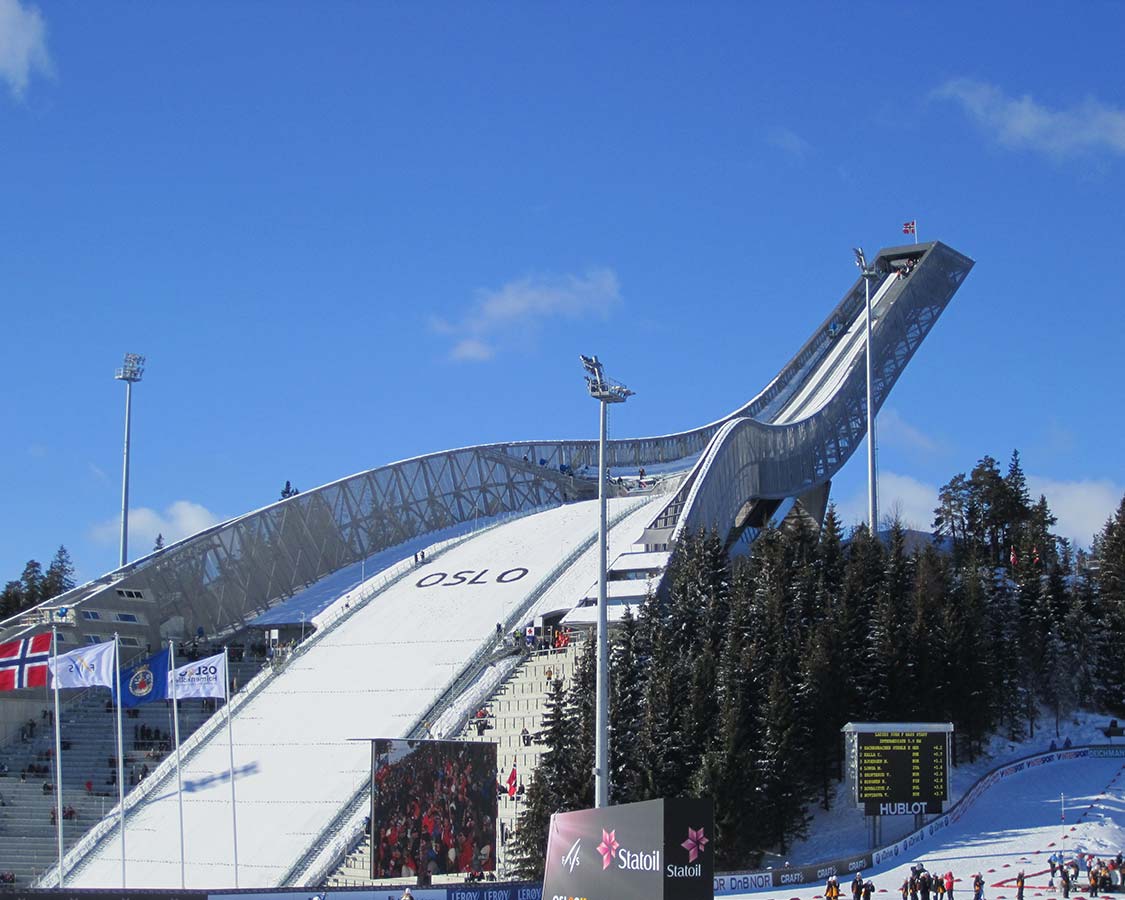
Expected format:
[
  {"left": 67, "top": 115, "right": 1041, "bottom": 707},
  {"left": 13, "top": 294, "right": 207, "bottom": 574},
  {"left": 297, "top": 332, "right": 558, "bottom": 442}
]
[{"left": 853, "top": 725, "right": 950, "bottom": 816}]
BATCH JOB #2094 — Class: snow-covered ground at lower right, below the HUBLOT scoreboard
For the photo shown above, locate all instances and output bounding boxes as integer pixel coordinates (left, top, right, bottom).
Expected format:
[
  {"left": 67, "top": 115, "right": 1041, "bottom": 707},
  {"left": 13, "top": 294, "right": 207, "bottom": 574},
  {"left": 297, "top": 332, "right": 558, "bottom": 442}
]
[{"left": 723, "top": 747, "right": 1125, "bottom": 900}]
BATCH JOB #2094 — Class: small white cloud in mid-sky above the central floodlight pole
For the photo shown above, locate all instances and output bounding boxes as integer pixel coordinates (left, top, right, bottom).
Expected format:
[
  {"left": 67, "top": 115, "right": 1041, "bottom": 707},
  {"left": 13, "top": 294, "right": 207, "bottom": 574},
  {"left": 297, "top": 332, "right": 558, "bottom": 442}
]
[{"left": 430, "top": 269, "right": 621, "bottom": 362}]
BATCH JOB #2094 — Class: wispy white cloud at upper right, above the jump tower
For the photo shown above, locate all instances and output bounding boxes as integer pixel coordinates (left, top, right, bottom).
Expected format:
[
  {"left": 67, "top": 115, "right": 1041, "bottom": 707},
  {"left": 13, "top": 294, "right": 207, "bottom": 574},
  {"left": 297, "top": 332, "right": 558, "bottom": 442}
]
[{"left": 934, "top": 78, "right": 1125, "bottom": 158}]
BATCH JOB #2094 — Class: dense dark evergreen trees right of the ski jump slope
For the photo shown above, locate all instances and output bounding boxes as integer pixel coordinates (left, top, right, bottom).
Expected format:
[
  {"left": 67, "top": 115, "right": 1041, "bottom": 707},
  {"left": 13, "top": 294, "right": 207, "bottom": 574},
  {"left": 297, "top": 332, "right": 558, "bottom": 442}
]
[{"left": 509, "top": 452, "right": 1125, "bottom": 879}]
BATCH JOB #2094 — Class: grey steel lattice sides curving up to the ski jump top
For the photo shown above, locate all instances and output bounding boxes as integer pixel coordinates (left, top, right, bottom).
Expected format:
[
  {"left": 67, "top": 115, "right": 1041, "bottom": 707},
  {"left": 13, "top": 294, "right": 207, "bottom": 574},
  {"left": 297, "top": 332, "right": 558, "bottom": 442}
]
[{"left": 0, "top": 242, "right": 973, "bottom": 646}]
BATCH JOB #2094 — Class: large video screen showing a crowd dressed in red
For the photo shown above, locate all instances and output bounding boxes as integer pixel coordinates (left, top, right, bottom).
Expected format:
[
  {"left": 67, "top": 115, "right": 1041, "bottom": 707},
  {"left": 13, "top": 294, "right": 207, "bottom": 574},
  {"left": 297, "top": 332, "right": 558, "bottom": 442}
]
[{"left": 370, "top": 739, "right": 496, "bottom": 879}]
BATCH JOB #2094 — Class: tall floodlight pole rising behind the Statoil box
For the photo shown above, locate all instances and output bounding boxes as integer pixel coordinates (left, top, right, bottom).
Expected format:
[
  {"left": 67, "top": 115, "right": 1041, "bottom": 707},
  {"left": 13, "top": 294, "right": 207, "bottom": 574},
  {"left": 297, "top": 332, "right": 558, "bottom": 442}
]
[{"left": 578, "top": 354, "right": 633, "bottom": 809}]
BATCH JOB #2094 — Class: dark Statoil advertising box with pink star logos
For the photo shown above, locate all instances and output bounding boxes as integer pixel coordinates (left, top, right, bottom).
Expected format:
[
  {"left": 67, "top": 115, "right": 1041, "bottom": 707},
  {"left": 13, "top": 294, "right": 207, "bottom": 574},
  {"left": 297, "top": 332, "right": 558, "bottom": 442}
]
[{"left": 543, "top": 799, "right": 714, "bottom": 900}]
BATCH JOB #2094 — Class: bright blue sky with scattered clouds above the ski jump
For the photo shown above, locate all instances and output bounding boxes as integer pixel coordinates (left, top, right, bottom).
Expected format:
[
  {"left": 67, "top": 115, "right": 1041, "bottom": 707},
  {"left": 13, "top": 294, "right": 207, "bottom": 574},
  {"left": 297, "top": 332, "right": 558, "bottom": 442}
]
[{"left": 0, "top": 0, "right": 1125, "bottom": 581}]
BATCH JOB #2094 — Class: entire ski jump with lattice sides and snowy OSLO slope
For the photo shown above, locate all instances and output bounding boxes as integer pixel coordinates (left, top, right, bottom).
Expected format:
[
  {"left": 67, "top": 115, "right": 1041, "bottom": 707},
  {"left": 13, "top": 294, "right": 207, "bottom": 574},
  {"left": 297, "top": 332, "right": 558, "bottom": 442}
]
[{"left": 13, "top": 242, "right": 973, "bottom": 888}]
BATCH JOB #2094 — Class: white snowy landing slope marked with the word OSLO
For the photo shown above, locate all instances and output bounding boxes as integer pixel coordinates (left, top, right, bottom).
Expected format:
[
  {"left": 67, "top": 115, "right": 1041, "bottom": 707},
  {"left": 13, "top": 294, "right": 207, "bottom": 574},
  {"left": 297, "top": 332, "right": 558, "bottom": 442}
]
[{"left": 68, "top": 500, "right": 652, "bottom": 888}]
